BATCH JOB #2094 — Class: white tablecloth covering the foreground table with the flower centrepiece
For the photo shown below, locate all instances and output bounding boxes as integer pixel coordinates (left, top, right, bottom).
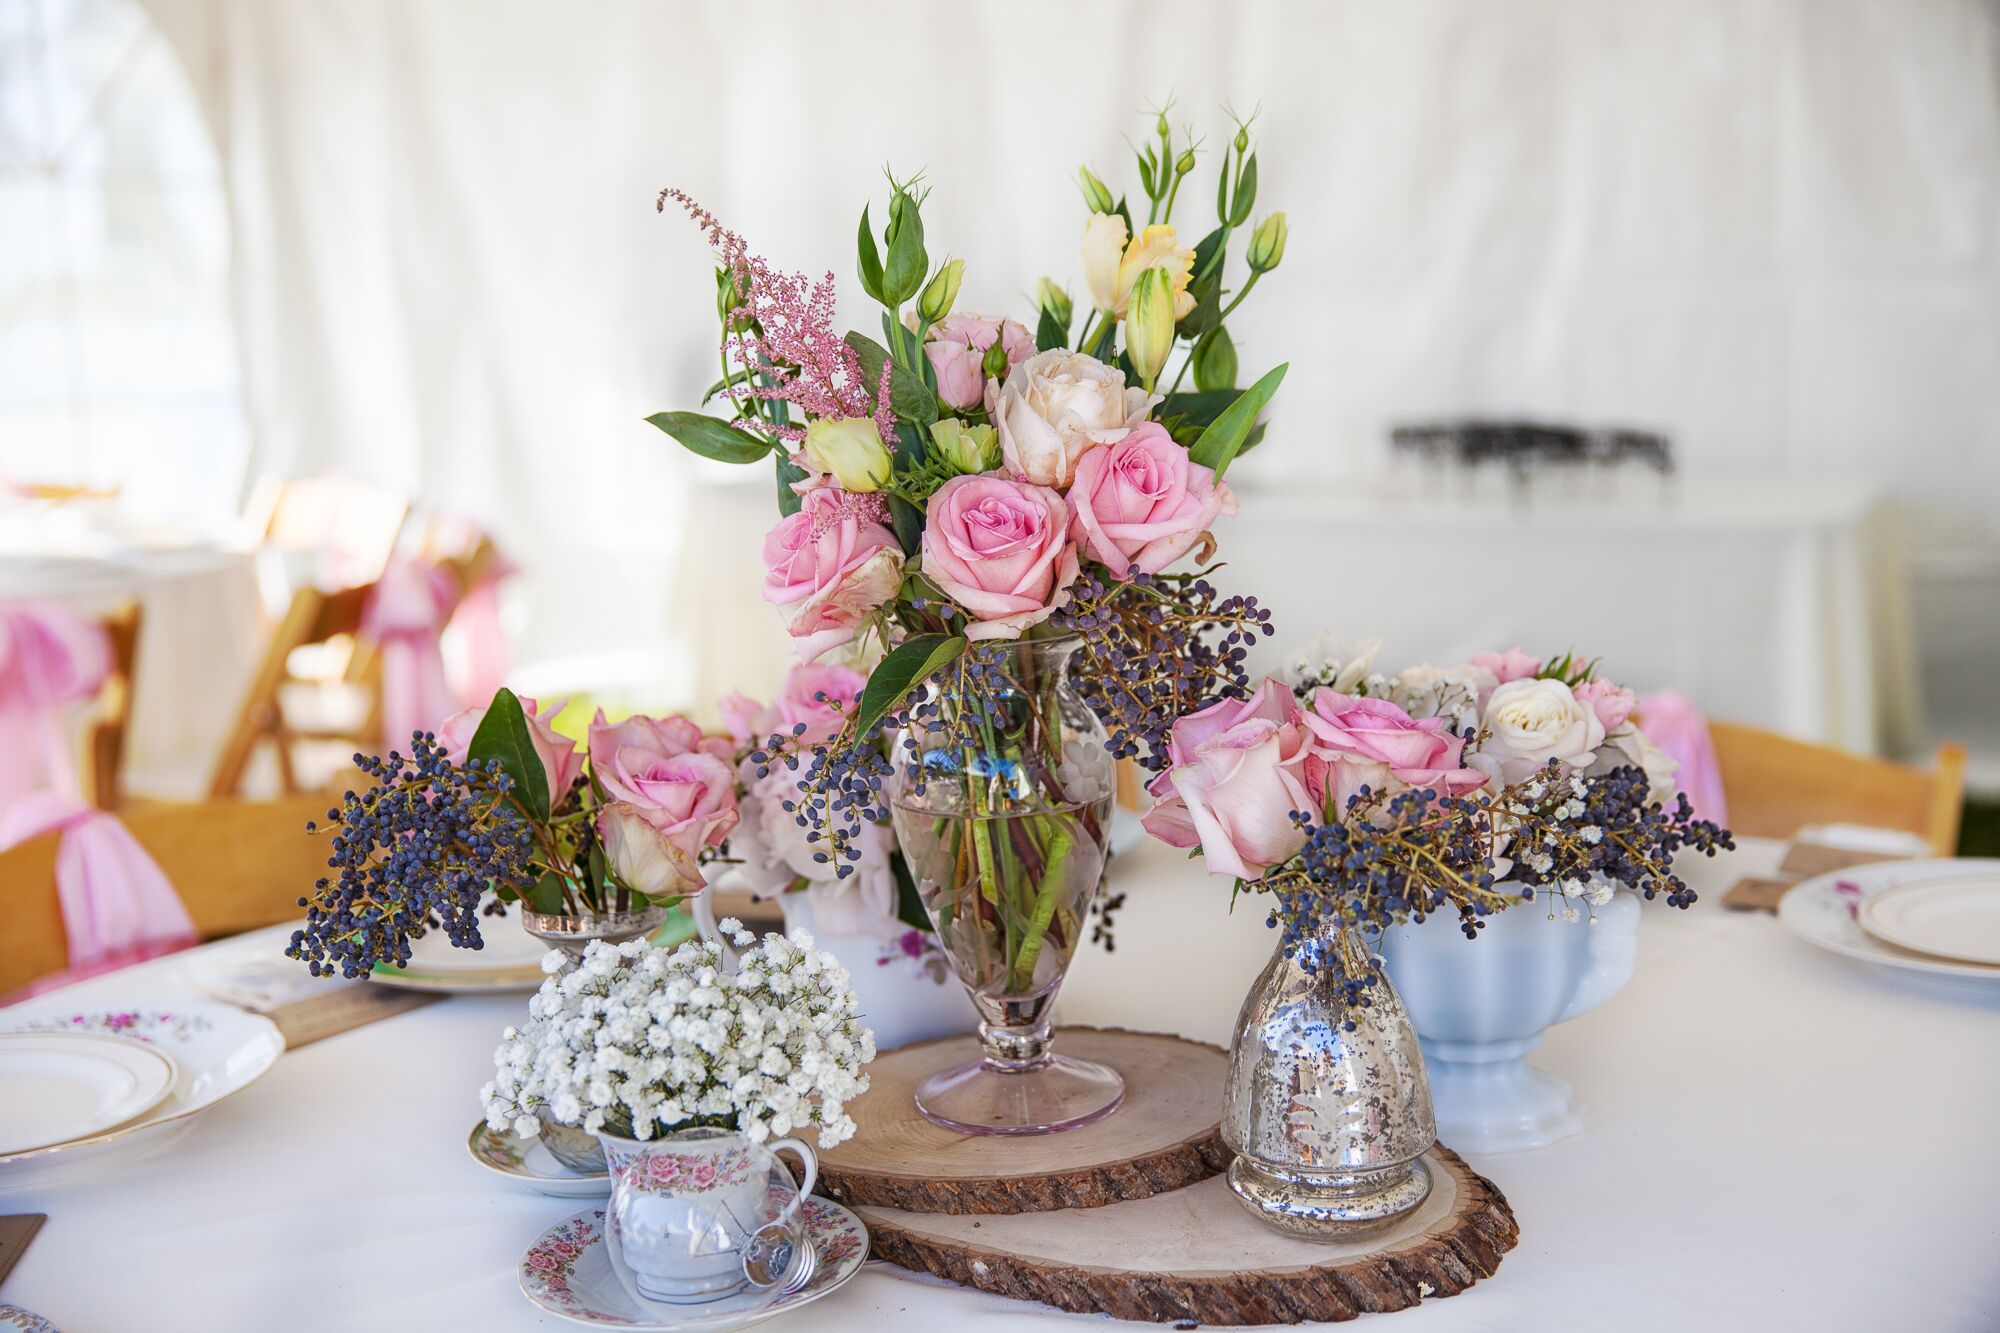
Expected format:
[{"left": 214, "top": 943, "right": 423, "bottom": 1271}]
[{"left": 0, "top": 845, "right": 2000, "bottom": 1333}]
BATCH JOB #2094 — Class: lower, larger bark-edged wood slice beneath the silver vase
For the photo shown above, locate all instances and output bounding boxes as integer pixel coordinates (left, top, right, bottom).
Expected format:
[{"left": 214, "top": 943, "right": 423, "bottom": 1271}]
[{"left": 856, "top": 1147, "right": 1520, "bottom": 1325}]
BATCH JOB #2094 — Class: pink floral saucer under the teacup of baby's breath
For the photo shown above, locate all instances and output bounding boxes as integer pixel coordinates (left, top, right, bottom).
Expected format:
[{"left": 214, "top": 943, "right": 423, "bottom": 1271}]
[{"left": 520, "top": 1195, "right": 868, "bottom": 1333}]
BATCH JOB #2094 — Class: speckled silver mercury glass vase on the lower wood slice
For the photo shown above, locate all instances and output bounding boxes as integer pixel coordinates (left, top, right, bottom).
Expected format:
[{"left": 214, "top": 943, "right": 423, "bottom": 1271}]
[{"left": 1222, "top": 912, "right": 1438, "bottom": 1239}]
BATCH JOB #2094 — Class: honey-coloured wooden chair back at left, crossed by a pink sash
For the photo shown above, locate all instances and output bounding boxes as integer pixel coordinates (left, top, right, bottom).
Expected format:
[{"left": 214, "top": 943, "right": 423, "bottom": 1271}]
[{"left": 0, "top": 797, "right": 326, "bottom": 995}]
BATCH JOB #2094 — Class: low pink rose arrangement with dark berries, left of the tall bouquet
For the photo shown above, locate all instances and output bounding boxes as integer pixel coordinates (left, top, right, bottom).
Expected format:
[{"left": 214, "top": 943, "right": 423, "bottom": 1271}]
[{"left": 286, "top": 689, "right": 740, "bottom": 977}]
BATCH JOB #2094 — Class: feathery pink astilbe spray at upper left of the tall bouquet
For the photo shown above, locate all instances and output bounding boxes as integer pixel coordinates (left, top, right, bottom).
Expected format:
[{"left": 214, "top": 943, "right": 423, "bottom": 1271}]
[{"left": 658, "top": 188, "right": 896, "bottom": 444}]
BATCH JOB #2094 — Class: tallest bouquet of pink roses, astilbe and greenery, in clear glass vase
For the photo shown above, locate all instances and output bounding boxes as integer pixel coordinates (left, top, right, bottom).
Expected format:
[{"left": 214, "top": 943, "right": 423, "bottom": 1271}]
[{"left": 648, "top": 112, "right": 1286, "bottom": 872}]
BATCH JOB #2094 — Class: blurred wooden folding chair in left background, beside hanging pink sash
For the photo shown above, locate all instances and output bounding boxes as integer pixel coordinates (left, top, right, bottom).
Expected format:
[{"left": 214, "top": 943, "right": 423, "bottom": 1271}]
[{"left": 208, "top": 584, "right": 382, "bottom": 799}]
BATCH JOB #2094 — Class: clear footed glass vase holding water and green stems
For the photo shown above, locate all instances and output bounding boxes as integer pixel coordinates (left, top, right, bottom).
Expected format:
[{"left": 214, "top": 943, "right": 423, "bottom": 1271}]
[{"left": 892, "top": 636, "right": 1124, "bottom": 1135}]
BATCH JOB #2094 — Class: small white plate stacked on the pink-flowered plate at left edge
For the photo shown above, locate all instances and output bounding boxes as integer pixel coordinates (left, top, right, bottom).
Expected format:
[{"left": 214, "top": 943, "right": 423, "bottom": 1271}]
[{"left": 0, "top": 1033, "right": 174, "bottom": 1157}]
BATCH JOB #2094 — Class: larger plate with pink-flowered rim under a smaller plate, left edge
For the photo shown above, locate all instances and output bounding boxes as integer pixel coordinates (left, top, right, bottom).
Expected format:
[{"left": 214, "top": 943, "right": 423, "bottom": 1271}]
[{"left": 0, "top": 991, "right": 284, "bottom": 1193}]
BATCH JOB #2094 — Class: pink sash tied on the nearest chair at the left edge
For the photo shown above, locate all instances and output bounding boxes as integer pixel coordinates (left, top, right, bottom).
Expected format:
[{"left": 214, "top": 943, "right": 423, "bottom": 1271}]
[{"left": 0, "top": 602, "right": 196, "bottom": 981}]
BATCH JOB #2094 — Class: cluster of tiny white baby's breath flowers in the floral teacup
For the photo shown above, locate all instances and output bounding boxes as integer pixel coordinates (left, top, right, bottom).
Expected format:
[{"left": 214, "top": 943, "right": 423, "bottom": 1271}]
[{"left": 480, "top": 921, "right": 874, "bottom": 1147}]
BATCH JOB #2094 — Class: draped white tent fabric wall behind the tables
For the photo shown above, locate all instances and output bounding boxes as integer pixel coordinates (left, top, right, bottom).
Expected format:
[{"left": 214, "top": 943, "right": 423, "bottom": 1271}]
[{"left": 144, "top": 0, "right": 2000, "bottom": 712}]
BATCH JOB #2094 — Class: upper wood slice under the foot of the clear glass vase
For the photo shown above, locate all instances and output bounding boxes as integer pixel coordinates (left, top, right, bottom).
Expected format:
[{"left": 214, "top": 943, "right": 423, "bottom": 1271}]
[{"left": 818, "top": 1027, "right": 1230, "bottom": 1215}]
